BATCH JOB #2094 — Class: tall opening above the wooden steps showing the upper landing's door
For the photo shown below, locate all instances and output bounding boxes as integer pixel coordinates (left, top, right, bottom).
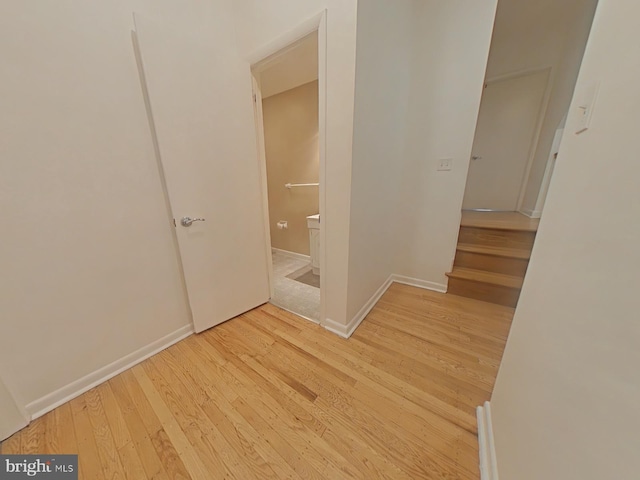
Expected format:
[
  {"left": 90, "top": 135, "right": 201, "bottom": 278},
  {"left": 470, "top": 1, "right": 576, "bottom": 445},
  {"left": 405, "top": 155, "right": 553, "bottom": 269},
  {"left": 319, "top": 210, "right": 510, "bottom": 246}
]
[{"left": 463, "top": 0, "right": 597, "bottom": 218}]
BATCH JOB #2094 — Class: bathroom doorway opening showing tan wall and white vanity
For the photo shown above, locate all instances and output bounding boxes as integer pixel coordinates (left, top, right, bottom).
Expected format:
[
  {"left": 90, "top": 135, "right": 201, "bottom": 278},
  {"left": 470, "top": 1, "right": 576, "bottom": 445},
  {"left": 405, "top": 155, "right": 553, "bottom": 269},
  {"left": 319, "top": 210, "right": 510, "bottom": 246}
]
[{"left": 252, "top": 30, "right": 322, "bottom": 323}]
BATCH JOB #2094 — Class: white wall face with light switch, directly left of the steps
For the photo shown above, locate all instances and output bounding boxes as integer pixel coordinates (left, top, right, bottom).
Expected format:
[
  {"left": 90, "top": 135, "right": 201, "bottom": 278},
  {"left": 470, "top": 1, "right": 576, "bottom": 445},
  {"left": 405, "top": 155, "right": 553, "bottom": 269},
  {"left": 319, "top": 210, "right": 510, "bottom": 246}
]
[{"left": 396, "top": 0, "right": 497, "bottom": 287}]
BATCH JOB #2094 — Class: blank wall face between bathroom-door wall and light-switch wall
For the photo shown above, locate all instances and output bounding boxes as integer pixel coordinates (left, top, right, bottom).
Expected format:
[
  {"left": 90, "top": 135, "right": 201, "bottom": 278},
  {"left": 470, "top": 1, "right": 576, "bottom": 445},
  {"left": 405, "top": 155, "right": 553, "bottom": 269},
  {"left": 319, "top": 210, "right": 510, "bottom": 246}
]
[{"left": 347, "top": 0, "right": 414, "bottom": 319}]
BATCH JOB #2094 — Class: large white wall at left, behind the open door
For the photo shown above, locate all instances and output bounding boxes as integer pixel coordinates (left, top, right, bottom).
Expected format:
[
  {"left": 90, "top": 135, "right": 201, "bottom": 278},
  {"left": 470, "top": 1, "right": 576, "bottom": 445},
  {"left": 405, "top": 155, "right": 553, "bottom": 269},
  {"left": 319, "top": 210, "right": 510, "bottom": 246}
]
[{"left": 0, "top": 0, "right": 238, "bottom": 412}]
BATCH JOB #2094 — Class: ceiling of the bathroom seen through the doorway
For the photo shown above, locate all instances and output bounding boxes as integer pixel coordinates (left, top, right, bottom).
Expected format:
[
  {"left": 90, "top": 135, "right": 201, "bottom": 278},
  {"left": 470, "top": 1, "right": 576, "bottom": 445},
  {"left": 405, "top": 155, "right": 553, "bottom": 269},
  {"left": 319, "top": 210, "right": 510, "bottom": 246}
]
[{"left": 260, "top": 32, "right": 318, "bottom": 98}]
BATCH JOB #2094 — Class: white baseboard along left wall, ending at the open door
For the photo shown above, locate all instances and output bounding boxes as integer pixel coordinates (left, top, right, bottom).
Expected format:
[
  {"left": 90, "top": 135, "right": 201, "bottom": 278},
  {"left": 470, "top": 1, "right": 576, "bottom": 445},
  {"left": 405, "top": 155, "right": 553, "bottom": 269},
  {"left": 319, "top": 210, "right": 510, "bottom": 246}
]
[{"left": 25, "top": 325, "right": 194, "bottom": 420}]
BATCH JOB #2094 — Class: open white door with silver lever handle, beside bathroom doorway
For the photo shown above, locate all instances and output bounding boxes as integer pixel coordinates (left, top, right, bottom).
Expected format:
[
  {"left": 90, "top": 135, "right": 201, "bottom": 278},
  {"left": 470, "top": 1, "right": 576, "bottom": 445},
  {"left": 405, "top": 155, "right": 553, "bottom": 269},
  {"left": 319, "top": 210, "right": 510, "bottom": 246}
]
[{"left": 135, "top": 15, "right": 269, "bottom": 332}]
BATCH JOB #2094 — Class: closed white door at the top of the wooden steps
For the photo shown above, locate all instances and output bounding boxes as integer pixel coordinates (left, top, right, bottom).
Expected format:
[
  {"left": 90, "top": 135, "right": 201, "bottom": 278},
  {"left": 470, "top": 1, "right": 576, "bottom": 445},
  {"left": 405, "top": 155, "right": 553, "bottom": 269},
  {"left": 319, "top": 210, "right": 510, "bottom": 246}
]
[{"left": 462, "top": 70, "right": 549, "bottom": 211}]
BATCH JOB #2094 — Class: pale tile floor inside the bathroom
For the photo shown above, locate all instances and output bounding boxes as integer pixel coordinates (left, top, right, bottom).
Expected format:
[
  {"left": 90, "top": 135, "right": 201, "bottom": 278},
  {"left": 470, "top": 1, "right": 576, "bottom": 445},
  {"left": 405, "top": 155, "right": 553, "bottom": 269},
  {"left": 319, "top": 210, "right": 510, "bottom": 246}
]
[{"left": 271, "top": 251, "right": 320, "bottom": 323}]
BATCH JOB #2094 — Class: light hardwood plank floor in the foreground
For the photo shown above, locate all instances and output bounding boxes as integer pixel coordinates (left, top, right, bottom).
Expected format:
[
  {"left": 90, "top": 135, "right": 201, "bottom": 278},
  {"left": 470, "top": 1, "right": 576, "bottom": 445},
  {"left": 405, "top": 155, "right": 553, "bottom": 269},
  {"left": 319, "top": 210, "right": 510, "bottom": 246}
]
[{"left": 2, "top": 284, "right": 513, "bottom": 480}]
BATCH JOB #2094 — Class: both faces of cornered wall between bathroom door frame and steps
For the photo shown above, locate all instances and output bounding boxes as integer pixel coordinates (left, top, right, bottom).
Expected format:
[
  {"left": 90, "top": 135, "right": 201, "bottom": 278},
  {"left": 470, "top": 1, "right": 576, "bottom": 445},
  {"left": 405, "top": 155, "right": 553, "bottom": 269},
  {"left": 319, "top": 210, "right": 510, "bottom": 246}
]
[{"left": 348, "top": 0, "right": 496, "bottom": 318}]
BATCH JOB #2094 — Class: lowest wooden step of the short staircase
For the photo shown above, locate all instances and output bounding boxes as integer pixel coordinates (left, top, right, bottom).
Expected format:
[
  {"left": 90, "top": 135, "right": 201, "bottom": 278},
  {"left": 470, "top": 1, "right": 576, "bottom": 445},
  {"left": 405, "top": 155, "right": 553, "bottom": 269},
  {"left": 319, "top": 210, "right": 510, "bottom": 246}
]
[{"left": 447, "top": 267, "right": 523, "bottom": 307}]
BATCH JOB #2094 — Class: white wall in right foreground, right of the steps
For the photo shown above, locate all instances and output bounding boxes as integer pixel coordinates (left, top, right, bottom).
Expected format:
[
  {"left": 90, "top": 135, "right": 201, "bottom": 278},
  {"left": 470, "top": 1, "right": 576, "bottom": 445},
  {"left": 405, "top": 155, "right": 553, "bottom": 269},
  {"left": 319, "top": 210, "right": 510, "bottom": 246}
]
[{"left": 491, "top": 0, "right": 640, "bottom": 480}]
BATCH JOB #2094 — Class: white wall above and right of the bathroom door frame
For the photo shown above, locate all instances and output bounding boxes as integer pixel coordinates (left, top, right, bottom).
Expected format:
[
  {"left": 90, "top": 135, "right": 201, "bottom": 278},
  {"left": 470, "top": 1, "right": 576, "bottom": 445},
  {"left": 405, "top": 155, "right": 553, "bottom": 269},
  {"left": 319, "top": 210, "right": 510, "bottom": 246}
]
[{"left": 233, "top": 0, "right": 356, "bottom": 324}]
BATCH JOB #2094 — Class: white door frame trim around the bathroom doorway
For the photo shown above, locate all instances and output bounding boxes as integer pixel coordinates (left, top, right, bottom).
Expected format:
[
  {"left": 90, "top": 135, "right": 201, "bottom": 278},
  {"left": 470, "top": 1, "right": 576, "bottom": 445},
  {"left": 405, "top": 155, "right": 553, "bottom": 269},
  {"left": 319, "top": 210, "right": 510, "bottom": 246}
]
[{"left": 247, "top": 9, "right": 327, "bottom": 325}]
